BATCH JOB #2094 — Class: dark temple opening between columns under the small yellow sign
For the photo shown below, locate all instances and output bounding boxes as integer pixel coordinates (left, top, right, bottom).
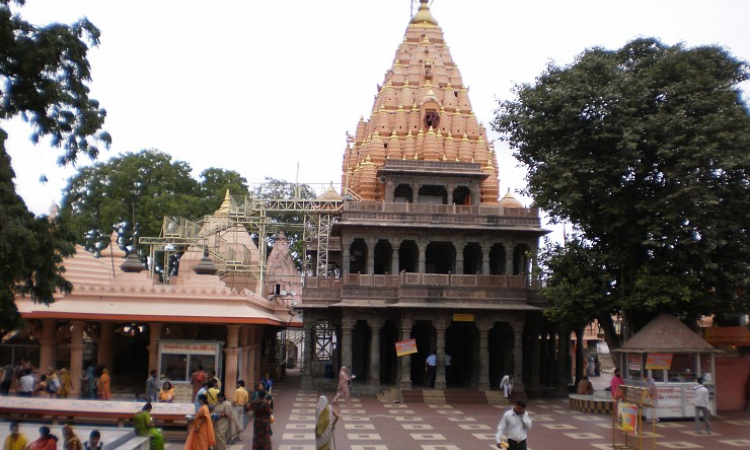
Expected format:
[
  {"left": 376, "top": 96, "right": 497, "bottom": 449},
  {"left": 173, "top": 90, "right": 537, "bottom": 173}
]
[{"left": 445, "top": 322, "right": 479, "bottom": 388}]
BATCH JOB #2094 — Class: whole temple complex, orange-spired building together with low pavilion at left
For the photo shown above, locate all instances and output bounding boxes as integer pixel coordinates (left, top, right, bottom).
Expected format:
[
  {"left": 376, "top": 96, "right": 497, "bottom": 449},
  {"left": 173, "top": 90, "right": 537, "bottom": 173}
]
[{"left": 2, "top": 0, "right": 569, "bottom": 396}]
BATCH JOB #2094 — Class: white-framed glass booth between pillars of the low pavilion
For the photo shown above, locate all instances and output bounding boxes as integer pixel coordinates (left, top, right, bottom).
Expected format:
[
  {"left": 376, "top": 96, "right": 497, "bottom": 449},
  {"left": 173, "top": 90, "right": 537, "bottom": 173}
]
[{"left": 158, "top": 340, "right": 223, "bottom": 403}]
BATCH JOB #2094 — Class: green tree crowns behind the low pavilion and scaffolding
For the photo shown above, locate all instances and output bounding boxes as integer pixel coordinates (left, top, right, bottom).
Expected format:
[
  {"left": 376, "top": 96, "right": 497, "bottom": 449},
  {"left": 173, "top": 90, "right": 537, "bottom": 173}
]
[{"left": 62, "top": 150, "right": 248, "bottom": 252}]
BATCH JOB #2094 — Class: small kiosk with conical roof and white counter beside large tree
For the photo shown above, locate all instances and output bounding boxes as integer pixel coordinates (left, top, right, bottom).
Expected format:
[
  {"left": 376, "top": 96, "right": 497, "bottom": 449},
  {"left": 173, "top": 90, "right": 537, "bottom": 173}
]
[{"left": 614, "top": 314, "right": 720, "bottom": 419}]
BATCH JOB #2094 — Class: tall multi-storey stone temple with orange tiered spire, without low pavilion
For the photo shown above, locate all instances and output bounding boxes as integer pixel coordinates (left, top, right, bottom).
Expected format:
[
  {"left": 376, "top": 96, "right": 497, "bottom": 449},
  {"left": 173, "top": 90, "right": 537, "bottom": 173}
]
[{"left": 300, "top": 0, "right": 568, "bottom": 393}]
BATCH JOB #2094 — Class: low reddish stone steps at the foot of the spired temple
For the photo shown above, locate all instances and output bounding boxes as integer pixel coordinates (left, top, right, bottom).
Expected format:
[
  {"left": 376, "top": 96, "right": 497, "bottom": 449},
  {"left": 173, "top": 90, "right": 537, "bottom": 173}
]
[{"left": 378, "top": 387, "right": 509, "bottom": 405}]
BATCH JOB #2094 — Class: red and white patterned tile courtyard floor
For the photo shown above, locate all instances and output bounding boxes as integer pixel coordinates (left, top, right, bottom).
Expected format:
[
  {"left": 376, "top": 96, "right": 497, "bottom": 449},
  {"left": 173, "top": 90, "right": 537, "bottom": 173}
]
[{"left": 167, "top": 372, "right": 750, "bottom": 450}]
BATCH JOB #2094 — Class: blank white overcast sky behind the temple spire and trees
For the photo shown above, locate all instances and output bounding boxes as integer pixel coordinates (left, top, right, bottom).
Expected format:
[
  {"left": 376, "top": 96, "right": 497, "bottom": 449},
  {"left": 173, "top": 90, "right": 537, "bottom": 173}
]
[{"left": 3, "top": 0, "right": 750, "bottom": 239}]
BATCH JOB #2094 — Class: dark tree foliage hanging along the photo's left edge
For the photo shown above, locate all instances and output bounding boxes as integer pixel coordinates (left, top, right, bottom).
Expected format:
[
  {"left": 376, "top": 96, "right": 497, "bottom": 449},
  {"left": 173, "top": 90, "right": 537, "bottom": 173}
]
[{"left": 0, "top": 0, "right": 111, "bottom": 331}]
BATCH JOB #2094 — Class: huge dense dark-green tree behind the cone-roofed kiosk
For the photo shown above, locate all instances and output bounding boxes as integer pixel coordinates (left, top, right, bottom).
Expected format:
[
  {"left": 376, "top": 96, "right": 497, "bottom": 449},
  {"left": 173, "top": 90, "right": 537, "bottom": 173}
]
[{"left": 494, "top": 39, "right": 750, "bottom": 340}]
